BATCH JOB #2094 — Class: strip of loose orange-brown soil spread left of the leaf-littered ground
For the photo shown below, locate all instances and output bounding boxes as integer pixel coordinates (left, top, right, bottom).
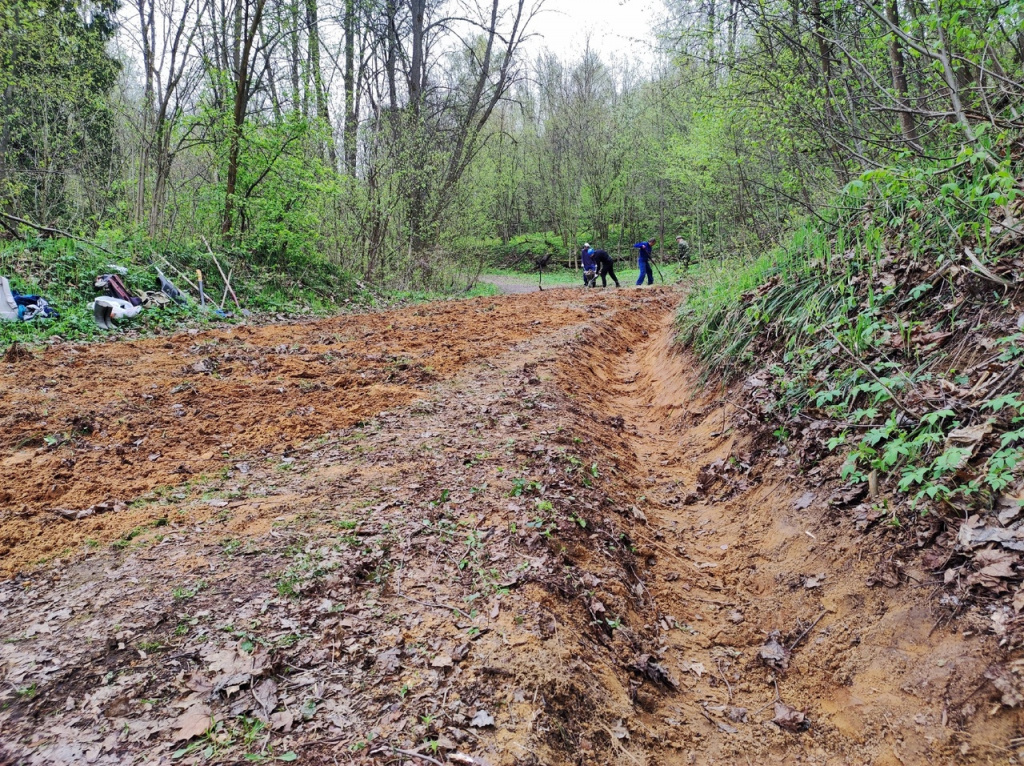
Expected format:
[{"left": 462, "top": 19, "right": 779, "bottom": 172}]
[{"left": 0, "top": 298, "right": 584, "bottom": 577}]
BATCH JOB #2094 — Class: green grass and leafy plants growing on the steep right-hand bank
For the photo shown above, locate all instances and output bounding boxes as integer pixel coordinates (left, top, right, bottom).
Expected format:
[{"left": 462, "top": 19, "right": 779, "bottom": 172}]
[{"left": 679, "top": 143, "right": 1024, "bottom": 514}]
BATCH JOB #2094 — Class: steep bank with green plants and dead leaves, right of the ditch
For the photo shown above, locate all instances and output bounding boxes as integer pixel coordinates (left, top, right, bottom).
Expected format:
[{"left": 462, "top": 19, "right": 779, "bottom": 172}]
[{"left": 679, "top": 146, "right": 1024, "bottom": 593}]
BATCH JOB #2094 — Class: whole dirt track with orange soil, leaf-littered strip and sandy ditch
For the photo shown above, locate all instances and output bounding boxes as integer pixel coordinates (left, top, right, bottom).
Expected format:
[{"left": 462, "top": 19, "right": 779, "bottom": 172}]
[{"left": 0, "top": 289, "right": 1022, "bottom": 764}]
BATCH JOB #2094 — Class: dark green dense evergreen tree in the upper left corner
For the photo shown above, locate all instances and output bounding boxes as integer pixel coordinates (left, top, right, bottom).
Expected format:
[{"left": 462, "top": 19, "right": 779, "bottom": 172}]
[{"left": 0, "top": 0, "right": 121, "bottom": 226}]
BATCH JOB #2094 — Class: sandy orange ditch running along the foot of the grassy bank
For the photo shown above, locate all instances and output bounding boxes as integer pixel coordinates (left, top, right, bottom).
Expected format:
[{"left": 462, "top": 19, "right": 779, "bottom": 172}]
[{"left": 564, "top": 296, "right": 1022, "bottom": 764}]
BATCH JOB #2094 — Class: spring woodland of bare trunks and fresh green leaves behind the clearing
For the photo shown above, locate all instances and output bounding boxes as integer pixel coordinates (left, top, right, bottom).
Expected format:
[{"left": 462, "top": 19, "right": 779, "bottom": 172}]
[{"left": 0, "top": 0, "right": 1024, "bottom": 290}]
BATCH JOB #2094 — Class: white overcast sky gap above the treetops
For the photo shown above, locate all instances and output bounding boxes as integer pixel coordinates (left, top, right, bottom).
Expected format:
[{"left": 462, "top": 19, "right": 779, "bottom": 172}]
[{"left": 520, "top": 0, "right": 665, "bottom": 62}]
